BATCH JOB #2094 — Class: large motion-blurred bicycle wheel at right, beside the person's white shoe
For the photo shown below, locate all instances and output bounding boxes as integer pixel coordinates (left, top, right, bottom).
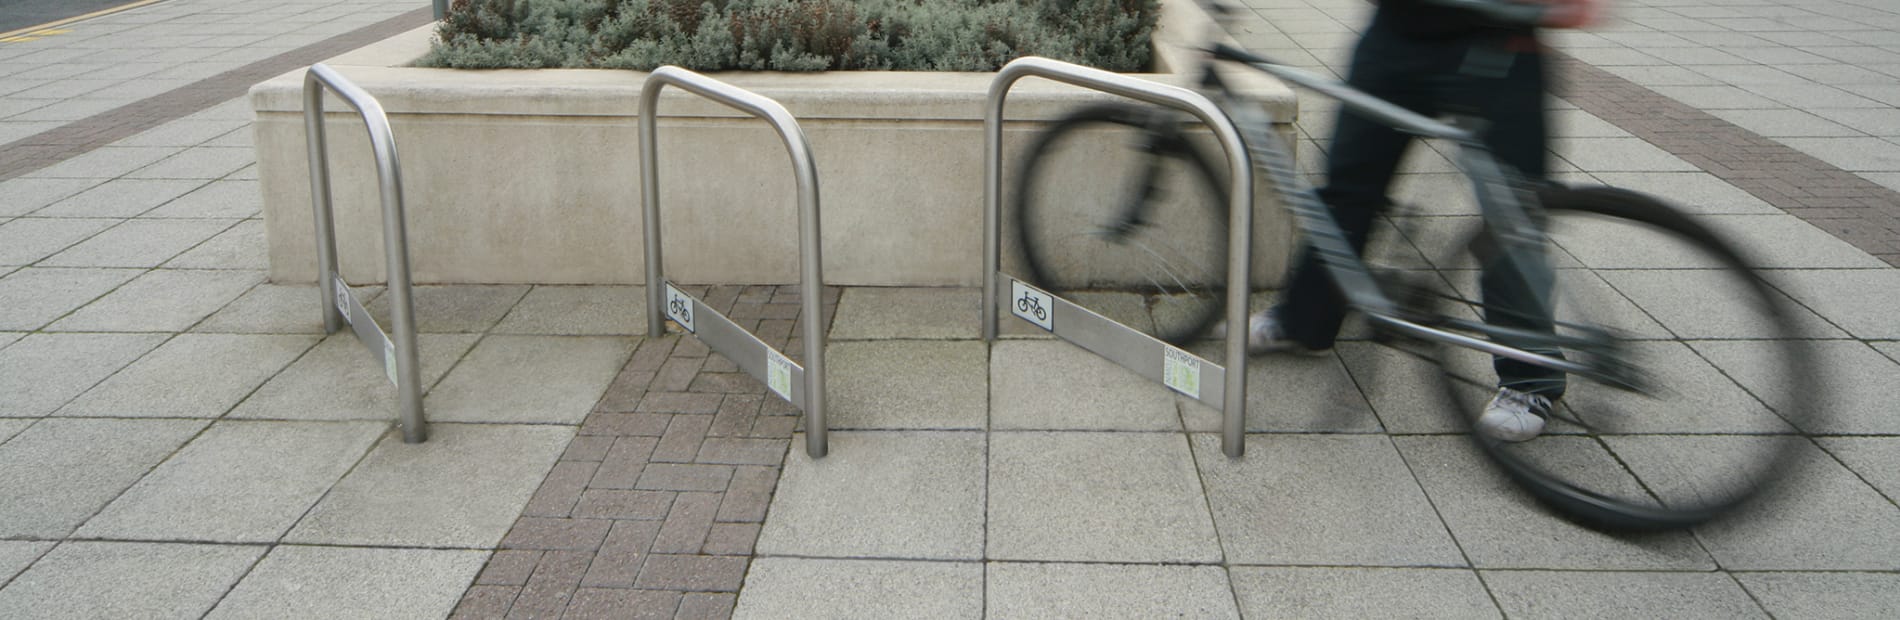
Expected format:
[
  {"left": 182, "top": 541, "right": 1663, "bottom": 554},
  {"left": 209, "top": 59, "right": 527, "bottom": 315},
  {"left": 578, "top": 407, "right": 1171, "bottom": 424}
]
[{"left": 1440, "top": 188, "right": 1822, "bottom": 531}]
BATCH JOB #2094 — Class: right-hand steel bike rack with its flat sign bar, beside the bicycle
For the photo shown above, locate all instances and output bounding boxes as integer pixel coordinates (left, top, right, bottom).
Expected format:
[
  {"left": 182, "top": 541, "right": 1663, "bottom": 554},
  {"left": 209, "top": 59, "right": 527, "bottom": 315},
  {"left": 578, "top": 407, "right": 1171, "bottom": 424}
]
[{"left": 982, "top": 57, "right": 1254, "bottom": 456}]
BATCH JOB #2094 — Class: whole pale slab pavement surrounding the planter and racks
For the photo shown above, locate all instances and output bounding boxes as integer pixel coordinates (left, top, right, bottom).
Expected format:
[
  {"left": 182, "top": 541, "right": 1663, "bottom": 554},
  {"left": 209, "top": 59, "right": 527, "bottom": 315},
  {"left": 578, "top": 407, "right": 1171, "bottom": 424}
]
[{"left": 0, "top": 0, "right": 1900, "bottom": 618}]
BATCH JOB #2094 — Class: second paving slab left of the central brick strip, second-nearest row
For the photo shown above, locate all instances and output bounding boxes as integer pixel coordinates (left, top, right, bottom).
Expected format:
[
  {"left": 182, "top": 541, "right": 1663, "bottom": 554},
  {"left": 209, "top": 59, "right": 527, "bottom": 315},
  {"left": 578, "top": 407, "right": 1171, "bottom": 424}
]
[{"left": 74, "top": 420, "right": 390, "bottom": 544}]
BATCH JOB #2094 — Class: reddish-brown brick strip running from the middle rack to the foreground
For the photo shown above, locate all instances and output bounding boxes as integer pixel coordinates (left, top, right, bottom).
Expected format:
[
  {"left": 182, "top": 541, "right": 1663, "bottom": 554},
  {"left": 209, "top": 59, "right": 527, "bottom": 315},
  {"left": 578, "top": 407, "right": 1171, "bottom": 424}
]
[{"left": 452, "top": 285, "right": 840, "bottom": 618}]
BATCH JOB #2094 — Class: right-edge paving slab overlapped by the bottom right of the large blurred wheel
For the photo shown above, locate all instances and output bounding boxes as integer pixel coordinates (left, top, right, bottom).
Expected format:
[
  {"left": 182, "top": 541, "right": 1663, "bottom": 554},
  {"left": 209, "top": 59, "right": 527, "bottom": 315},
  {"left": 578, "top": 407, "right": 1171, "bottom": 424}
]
[{"left": 1617, "top": 445, "right": 1900, "bottom": 571}]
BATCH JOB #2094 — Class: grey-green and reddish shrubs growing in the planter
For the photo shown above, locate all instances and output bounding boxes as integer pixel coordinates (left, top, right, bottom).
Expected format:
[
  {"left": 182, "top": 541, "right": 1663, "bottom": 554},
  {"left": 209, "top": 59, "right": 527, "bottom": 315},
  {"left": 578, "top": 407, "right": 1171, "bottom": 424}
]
[{"left": 418, "top": 0, "right": 1159, "bottom": 72}]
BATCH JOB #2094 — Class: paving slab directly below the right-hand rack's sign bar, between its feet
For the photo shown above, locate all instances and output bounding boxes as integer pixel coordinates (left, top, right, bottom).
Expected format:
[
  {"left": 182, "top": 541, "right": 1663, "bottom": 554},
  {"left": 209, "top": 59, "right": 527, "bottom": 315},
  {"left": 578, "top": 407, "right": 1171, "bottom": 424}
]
[{"left": 988, "top": 338, "right": 1182, "bottom": 430}]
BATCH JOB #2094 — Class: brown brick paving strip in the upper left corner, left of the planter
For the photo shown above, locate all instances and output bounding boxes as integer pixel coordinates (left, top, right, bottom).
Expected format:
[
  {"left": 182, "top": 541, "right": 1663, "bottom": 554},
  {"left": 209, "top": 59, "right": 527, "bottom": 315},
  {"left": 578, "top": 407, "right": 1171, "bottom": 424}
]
[{"left": 0, "top": 6, "right": 435, "bottom": 181}]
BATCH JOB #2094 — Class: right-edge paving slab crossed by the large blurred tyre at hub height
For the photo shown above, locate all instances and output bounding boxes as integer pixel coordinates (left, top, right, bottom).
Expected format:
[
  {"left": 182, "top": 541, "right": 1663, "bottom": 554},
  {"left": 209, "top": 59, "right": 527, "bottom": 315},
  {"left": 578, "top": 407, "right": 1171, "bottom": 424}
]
[{"left": 1689, "top": 340, "right": 1900, "bottom": 436}]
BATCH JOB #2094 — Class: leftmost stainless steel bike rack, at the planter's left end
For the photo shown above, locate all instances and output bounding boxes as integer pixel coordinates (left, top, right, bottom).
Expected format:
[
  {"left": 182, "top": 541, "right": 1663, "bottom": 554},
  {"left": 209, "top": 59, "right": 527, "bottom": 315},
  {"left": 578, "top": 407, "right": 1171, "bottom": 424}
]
[{"left": 304, "top": 65, "right": 429, "bottom": 443}]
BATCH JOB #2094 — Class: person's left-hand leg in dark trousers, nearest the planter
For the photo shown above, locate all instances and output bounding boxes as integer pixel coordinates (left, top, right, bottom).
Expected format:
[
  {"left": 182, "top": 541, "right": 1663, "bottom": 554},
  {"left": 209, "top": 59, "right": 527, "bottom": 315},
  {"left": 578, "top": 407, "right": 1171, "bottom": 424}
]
[{"left": 1273, "top": 23, "right": 1431, "bottom": 350}]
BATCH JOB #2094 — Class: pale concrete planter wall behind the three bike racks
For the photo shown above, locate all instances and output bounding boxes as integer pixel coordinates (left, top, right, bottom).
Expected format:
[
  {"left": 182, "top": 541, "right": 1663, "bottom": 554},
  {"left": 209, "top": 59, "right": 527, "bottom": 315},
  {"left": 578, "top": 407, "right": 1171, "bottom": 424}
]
[{"left": 251, "top": 2, "right": 1296, "bottom": 285}]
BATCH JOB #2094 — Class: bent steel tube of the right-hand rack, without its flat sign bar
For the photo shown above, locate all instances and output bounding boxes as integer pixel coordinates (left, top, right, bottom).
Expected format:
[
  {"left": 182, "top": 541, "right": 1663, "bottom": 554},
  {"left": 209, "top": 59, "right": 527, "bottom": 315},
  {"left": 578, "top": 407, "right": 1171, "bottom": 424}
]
[{"left": 982, "top": 57, "right": 1254, "bottom": 456}]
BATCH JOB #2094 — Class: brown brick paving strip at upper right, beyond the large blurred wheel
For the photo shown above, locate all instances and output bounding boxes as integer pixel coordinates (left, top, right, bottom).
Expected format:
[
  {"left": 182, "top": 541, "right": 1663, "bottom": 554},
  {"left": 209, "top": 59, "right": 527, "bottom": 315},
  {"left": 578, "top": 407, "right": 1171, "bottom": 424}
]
[{"left": 1552, "top": 53, "right": 1900, "bottom": 266}]
